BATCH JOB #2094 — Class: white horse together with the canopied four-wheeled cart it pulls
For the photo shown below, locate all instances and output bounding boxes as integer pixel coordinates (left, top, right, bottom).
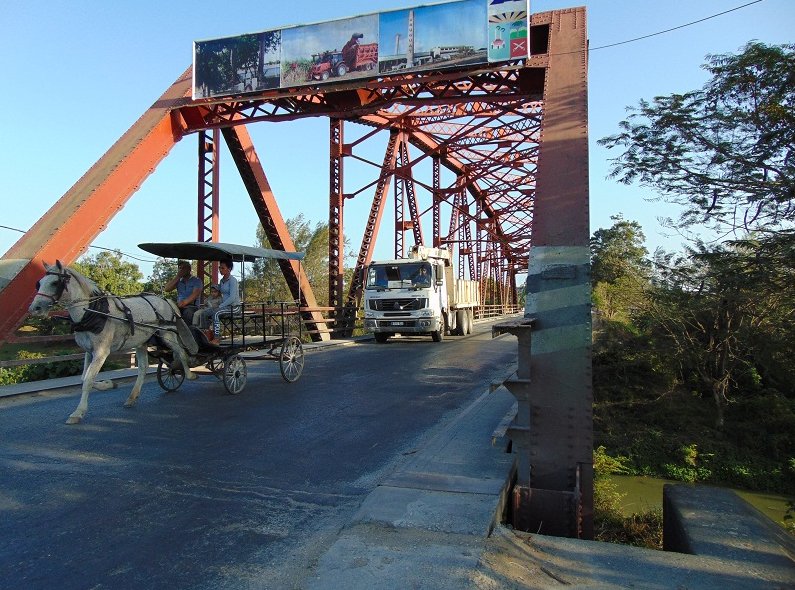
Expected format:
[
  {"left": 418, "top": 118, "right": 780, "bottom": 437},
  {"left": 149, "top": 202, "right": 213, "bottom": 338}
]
[{"left": 29, "top": 242, "right": 304, "bottom": 424}]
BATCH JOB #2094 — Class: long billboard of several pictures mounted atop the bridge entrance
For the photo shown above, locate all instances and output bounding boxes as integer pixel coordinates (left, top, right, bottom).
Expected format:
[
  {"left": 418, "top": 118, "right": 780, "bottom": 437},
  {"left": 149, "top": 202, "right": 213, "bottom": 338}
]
[{"left": 193, "top": 0, "right": 529, "bottom": 99}]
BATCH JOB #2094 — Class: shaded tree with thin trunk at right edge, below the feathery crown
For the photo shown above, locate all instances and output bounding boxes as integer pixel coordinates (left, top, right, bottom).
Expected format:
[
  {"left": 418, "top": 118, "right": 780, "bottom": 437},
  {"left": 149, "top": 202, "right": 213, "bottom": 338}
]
[{"left": 647, "top": 235, "right": 795, "bottom": 428}]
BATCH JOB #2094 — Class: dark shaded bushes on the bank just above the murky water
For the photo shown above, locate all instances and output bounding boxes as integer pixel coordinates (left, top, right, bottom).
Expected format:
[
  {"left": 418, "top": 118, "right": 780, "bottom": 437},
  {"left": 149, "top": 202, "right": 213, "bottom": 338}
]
[{"left": 594, "top": 382, "right": 795, "bottom": 494}]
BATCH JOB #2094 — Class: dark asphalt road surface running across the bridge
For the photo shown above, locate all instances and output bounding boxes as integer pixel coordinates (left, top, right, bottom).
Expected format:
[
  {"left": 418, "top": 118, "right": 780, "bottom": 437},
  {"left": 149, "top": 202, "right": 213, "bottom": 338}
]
[{"left": 0, "top": 324, "right": 516, "bottom": 590}]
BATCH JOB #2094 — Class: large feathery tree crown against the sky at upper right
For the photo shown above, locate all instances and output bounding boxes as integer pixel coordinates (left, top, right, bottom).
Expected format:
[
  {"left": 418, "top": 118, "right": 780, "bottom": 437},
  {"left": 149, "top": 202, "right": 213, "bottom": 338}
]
[{"left": 600, "top": 42, "right": 795, "bottom": 233}]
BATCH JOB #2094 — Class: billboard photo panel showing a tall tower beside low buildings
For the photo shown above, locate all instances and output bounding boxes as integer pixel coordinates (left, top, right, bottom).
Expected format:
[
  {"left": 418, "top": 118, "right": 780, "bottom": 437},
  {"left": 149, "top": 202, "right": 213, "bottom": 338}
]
[{"left": 378, "top": 0, "right": 488, "bottom": 74}]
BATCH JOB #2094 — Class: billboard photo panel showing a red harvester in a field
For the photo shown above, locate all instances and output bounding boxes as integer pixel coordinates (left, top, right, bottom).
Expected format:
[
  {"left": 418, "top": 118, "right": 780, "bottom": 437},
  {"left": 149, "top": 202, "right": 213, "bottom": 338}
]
[{"left": 281, "top": 14, "right": 378, "bottom": 87}]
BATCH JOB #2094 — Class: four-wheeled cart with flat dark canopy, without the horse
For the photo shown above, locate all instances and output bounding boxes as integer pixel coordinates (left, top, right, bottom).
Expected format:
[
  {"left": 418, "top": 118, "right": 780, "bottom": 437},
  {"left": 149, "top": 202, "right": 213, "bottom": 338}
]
[{"left": 138, "top": 242, "right": 304, "bottom": 394}]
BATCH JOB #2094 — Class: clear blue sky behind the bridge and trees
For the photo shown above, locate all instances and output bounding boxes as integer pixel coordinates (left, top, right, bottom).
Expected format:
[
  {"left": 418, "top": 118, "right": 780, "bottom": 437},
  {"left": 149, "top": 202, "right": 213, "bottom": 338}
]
[{"left": 0, "top": 0, "right": 795, "bottom": 274}]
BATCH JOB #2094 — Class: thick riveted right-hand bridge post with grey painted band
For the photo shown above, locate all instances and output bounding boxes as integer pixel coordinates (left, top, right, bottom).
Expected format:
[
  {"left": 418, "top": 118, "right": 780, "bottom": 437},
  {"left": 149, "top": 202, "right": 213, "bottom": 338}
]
[{"left": 506, "top": 8, "right": 593, "bottom": 538}]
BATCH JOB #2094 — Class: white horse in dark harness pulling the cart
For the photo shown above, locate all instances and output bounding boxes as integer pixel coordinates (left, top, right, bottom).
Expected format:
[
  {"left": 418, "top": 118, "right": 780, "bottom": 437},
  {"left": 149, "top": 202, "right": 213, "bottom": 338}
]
[{"left": 28, "top": 260, "right": 198, "bottom": 424}]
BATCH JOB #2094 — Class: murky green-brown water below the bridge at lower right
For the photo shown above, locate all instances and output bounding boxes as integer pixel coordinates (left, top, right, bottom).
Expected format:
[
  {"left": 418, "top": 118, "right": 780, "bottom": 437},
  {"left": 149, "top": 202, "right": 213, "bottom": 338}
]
[{"left": 611, "top": 475, "right": 787, "bottom": 524}]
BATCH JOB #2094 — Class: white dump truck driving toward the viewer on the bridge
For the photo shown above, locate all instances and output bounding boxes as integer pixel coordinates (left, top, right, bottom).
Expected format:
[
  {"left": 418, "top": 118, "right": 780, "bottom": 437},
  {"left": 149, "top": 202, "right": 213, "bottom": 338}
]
[{"left": 364, "top": 246, "right": 480, "bottom": 343}]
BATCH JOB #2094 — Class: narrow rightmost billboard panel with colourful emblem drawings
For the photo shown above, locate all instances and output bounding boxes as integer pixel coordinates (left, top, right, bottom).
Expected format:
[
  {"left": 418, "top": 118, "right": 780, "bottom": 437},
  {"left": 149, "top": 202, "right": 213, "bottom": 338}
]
[{"left": 488, "top": 0, "right": 530, "bottom": 62}]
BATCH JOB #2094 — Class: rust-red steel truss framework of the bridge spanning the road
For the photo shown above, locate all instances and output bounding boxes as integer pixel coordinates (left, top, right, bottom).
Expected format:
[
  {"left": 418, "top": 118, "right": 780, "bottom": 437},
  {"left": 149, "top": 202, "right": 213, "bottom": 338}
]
[{"left": 0, "top": 7, "right": 593, "bottom": 538}]
